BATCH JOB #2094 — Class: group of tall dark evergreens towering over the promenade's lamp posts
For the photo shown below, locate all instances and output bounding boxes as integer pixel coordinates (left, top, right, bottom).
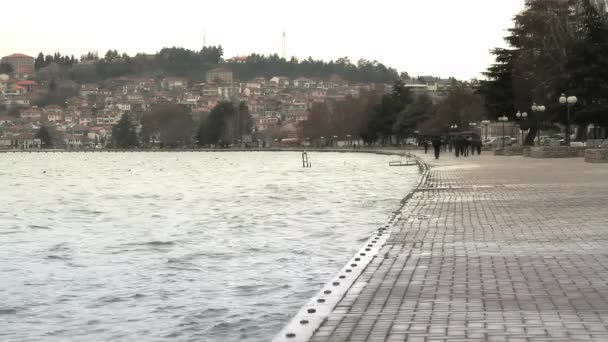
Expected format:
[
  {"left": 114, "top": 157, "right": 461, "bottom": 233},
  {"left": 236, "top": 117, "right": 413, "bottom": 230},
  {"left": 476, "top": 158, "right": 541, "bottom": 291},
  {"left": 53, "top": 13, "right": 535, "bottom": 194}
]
[{"left": 479, "top": 0, "right": 608, "bottom": 144}]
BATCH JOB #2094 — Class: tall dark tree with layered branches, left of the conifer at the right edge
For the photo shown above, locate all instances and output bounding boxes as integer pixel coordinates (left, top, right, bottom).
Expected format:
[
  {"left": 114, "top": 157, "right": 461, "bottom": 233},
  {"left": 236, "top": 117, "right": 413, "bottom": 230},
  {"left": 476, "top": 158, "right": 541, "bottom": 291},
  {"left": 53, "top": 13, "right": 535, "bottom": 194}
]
[{"left": 478, "top": 0, "right": 577, "bottom": 144}]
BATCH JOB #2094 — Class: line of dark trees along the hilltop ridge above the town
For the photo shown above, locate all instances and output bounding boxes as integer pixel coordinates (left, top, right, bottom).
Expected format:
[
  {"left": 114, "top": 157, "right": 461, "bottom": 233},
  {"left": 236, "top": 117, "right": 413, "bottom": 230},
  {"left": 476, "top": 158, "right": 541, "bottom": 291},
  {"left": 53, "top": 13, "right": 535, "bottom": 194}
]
[{"left": 29, "top": 46, "right": 399, "bottom": 83}]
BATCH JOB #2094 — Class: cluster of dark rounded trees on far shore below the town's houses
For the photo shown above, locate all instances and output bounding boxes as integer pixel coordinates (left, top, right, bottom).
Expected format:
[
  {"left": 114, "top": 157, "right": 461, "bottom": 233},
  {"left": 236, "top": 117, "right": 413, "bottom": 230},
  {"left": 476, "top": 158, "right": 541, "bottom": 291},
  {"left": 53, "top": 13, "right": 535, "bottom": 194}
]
[{"left": 112, "top": 102, "right": 252, "bottom": 148}]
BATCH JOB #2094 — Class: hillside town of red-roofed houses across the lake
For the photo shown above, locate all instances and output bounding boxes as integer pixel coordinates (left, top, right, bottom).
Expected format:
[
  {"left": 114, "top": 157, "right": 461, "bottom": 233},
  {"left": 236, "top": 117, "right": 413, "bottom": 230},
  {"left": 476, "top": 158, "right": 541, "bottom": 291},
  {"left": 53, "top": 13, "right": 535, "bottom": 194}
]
[{"left": 0, "top": 53, "right": 455, "bottom": 149}]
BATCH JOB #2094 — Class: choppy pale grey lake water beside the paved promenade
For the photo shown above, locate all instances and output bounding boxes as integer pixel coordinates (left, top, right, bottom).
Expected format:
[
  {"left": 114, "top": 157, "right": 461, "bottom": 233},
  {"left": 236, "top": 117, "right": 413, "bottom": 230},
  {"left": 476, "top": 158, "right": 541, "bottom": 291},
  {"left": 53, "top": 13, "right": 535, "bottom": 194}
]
[{"left": 0, "top": 153, "right": 418, "bottom": 341}]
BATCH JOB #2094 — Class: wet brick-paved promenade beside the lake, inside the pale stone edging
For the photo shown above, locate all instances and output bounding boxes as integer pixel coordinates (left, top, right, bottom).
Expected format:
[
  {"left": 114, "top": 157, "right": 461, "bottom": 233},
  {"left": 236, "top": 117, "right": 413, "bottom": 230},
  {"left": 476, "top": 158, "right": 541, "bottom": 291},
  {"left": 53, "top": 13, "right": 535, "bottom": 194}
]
[{"left": 310, "top": 155, "right": 608, "bottom": 342}]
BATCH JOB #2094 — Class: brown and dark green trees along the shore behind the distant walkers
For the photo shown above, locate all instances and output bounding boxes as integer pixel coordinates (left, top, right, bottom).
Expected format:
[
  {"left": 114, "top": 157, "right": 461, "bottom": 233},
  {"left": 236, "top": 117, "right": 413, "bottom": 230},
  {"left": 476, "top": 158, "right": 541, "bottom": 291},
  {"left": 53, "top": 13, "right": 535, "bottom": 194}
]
[{"left": 302, "top": 80, "right": 485, "bottom": 145}]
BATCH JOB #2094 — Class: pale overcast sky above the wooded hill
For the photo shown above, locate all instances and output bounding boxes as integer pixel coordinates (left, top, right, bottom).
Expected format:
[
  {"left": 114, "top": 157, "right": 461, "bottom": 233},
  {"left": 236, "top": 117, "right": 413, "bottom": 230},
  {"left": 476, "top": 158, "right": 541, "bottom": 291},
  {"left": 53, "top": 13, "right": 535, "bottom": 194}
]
[{"left": 0, "top": 0, "right": 524, "bottom": 79}]
